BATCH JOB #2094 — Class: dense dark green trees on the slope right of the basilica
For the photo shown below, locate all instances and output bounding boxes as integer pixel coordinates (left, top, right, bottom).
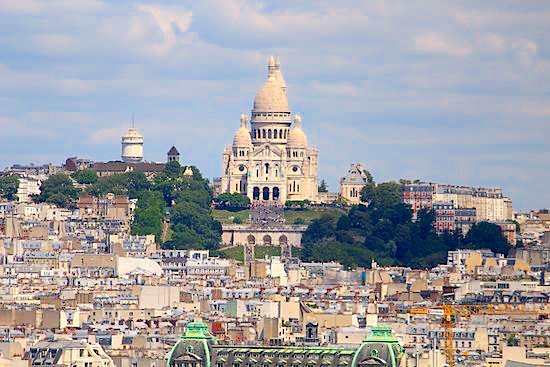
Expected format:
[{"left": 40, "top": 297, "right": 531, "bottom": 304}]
[{"left": 302, "top": 182, "right": 508, "bottom": 268}]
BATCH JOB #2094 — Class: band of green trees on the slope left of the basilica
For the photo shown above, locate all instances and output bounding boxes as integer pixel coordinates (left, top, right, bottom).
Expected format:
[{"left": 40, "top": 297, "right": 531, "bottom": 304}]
[{"left": 35, "top": 162, "right": 221, "bottom": 249}]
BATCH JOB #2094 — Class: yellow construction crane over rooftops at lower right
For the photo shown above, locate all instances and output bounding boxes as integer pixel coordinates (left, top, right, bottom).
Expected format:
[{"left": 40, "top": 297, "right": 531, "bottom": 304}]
[{"left": 407, "top": 304, "right": 548, "bottom": 367}]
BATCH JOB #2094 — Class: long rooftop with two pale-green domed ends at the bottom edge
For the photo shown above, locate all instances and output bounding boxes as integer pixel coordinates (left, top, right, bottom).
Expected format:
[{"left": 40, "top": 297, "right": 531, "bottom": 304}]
[{"left": 166, "top": 322, "right": 404, "bottom": 367}]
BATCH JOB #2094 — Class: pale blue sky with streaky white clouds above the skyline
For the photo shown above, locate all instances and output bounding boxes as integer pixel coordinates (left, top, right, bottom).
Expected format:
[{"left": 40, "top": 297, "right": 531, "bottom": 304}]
[{"left": 0, "top": 0, "right": 550, "bottom": 210}]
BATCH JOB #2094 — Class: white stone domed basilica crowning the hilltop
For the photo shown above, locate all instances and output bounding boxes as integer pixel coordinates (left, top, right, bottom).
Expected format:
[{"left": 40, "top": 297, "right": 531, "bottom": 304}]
[{"left": 221, "top": 56, "right": 317, "bottom": 204}]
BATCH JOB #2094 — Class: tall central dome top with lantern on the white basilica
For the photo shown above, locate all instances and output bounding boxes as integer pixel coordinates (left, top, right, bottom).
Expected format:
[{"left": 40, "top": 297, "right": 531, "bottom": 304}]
[{"left": 252, "top": 56, "right": 290, "bottom": 113}]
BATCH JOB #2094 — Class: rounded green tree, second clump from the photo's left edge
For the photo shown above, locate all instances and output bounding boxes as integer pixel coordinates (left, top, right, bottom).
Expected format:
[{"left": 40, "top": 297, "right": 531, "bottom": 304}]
[{"left": 34, "top": 173, "right": 79, "bottom": 208}]
